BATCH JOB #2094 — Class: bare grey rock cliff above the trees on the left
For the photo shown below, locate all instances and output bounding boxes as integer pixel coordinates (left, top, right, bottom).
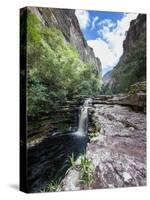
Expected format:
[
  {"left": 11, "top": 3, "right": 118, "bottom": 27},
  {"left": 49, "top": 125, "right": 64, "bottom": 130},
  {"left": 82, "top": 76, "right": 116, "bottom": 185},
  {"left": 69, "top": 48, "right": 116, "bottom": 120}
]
[{"left": 29, "top": 7, "right": 101, "bottom": 75}]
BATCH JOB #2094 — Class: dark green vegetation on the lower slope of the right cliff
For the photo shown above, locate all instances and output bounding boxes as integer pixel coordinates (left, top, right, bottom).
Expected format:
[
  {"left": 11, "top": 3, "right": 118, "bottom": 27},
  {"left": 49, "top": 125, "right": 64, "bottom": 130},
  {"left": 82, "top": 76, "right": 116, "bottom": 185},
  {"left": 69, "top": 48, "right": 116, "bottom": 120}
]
[{"left": 110, "top": 34, "right": 146, "bottom": 94}]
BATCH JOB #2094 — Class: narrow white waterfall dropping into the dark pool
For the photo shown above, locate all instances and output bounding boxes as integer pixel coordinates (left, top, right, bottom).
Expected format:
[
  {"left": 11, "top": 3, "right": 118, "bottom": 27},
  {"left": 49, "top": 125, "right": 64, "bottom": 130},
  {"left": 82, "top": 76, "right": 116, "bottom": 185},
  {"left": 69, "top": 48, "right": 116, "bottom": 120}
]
[{"left": 75, "top": 99, "right": 91, "bottom": 136}]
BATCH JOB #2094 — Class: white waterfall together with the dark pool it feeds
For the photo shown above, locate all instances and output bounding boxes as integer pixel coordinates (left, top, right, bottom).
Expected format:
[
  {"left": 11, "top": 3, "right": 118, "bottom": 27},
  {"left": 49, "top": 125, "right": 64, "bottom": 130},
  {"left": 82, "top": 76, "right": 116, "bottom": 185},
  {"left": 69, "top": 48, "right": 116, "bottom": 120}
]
[{"left": 28, "top": 99, "right": 91, "bottom": 192}]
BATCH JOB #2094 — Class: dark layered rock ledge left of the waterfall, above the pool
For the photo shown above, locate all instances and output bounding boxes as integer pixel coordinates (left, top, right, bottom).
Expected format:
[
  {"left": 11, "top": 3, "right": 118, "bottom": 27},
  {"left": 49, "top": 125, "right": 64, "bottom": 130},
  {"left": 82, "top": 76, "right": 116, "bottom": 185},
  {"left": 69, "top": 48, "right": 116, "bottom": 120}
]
[{"left": 28, "top": 98, "right": 83, "bottom": 146}]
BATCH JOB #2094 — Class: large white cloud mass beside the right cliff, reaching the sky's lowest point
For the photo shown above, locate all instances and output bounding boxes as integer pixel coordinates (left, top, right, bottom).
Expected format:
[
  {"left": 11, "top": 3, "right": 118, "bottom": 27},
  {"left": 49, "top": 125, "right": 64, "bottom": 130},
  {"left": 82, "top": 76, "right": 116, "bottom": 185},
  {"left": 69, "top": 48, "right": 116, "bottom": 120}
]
[{"left": 88, "top": 13, "right": 137, "bottom": 75}]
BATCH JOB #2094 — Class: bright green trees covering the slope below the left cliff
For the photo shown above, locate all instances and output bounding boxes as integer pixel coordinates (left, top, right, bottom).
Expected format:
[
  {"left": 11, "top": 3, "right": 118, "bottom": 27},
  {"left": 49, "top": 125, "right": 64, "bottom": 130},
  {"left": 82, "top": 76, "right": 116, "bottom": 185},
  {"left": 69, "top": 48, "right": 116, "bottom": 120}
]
[{"left": 27, "top": 11, "right": 100, "bottom": 116}]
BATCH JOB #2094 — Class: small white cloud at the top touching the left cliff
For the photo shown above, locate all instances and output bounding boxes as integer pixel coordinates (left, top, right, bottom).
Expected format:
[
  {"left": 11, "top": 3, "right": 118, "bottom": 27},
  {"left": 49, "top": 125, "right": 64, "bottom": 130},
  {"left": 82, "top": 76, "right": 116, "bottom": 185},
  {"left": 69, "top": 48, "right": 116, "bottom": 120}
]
[{"left": 75, "top": 10, "right": 90, "bottom": 29}]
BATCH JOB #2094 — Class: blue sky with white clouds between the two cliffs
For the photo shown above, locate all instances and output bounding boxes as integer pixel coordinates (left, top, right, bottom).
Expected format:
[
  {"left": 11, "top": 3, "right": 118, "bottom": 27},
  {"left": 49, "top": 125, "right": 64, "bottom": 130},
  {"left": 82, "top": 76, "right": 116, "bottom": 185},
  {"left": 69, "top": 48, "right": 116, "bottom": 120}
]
[{"left": 75, "top": 10, "right": 138, "bottom": 75}]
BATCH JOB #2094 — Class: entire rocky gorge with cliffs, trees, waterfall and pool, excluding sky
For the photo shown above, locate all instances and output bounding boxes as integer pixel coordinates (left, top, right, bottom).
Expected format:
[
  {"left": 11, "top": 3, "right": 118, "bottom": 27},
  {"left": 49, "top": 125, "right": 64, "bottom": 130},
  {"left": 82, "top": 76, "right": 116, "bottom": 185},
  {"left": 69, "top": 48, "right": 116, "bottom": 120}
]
[{"left": 21, "top": 7, "right": 146, "bottom": 192}]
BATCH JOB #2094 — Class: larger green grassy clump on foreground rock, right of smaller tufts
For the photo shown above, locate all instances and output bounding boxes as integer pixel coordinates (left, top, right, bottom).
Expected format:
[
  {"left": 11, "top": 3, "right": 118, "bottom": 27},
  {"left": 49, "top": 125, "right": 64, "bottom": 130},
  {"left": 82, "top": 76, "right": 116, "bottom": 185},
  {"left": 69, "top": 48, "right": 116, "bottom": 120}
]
[{"left": 80, "top": 156, "right": 93, "bottom": 187}]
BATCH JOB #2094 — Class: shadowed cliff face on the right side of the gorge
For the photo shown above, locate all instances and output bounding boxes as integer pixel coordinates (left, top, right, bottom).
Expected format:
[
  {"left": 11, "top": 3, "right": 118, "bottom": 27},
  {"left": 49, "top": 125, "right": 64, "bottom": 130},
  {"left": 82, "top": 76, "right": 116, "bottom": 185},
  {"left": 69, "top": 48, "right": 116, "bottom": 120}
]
[{"left": 103, "top": 14, "right": 146, "bottom": 93}]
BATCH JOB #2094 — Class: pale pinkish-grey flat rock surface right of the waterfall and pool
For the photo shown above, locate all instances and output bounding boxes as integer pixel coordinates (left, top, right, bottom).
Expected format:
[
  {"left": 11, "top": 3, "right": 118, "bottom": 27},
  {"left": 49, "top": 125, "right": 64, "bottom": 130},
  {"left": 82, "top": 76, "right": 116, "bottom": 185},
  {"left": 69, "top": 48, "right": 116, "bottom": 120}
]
[{"left": 59, "top": 100, "right": 146, "bottom": 191}]
